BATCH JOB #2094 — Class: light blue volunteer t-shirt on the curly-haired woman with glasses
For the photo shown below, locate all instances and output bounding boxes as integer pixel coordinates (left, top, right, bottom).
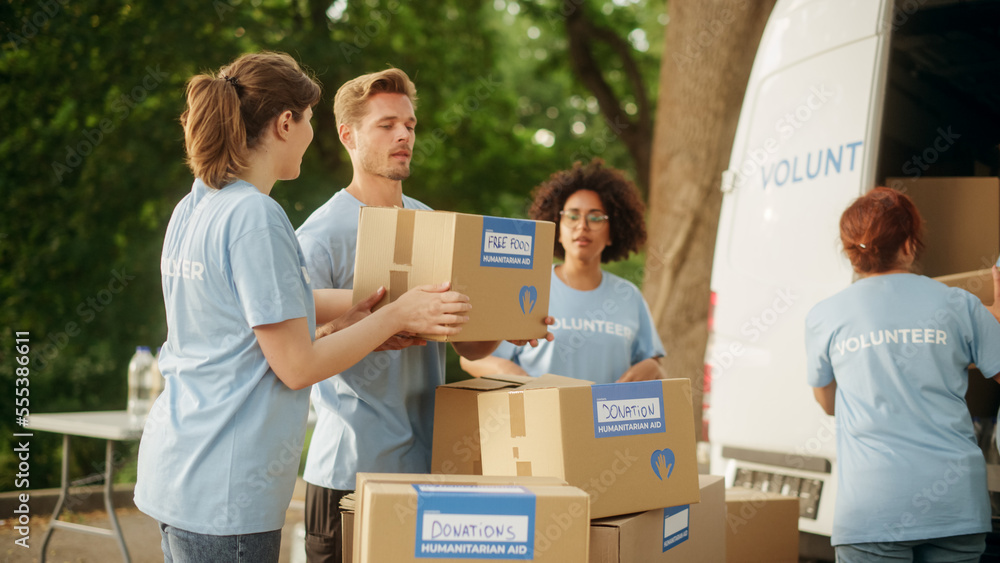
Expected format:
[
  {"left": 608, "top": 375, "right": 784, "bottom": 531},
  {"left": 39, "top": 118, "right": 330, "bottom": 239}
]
[{"left": 493, "top": 266, "right": 664, "bottom": 383}]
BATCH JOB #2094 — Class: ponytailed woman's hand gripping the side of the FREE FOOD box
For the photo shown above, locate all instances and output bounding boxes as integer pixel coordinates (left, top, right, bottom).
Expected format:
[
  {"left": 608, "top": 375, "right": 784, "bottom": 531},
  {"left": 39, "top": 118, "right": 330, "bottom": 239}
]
[{"left": 384, "top": 282, "right": 472, "bottom": 336}]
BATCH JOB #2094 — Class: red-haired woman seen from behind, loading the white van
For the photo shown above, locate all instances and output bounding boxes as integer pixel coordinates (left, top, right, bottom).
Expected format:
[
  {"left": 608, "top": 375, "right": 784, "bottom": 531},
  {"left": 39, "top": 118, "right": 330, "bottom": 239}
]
[{"left": 806, "top": 188, "right": 1000, "bottom": 563}]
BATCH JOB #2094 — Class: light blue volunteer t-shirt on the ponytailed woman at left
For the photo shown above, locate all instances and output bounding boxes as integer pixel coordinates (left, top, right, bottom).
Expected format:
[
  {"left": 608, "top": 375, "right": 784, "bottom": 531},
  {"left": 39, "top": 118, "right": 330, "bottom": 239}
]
[{"left": 135, "top": 180, "right": 316, "bottom": 535}]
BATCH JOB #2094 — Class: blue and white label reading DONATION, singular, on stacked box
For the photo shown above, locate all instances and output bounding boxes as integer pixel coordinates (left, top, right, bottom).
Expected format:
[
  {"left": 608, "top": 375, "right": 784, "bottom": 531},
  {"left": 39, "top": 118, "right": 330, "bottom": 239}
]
[{"left": 590, "top": 381, "right": 666, "bottom": 438}]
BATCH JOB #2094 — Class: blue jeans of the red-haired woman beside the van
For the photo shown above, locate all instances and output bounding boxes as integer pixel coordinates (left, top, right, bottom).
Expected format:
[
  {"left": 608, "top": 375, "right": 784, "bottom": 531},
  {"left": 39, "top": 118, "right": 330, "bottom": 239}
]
[{"left": 835, "top": 534, "right": 986, "bottom": 563}]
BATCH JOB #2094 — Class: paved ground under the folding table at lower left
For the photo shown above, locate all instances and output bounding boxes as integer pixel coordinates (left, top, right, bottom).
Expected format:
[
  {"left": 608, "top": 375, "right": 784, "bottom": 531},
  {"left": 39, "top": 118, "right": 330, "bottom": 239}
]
[{"left": 0, "top": 500, "right": 305, "bottom": 563}]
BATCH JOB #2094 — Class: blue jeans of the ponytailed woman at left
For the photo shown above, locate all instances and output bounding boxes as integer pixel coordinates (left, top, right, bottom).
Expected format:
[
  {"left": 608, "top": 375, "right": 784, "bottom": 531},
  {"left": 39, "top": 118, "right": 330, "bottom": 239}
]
[{"left": 159, "top": 522, "right": 281, "bottom": 563}]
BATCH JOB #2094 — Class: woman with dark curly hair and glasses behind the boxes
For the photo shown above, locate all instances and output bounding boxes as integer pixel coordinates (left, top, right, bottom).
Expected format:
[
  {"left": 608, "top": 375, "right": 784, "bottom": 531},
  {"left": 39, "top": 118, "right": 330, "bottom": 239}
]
[{"left": 461, "top": 159, "right": 664, "bottom": 383}]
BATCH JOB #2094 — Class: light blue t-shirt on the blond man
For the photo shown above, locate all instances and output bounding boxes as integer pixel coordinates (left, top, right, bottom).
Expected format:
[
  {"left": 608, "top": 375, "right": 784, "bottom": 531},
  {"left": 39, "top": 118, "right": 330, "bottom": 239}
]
[{"left": 297, "top": 190, "right": 446, "bottom": 491}]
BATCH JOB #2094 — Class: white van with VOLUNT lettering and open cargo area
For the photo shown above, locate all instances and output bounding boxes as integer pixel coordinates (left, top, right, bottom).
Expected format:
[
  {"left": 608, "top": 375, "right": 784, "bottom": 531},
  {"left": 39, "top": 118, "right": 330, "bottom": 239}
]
[{"left": 706, "top": 0, "right": 1000, "bottom": 535}]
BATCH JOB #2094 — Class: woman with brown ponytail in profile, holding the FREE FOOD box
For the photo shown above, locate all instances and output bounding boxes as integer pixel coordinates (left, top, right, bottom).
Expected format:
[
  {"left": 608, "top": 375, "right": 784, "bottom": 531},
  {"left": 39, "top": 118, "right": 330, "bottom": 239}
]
[{"left": 135, "top": 53, "right": 470, "bottom": 563}]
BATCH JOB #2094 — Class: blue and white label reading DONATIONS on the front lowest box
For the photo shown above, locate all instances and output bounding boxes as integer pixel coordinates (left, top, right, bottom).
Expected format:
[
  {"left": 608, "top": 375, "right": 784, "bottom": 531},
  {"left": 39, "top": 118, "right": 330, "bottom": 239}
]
[{"left": 413, "top": 485, "right": 535, "bottom": 560}]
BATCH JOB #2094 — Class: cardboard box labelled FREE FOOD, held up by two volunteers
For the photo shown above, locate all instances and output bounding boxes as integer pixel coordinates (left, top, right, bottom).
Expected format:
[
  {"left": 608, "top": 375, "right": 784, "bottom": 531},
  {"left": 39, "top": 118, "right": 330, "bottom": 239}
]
[{"left": 354, "top": 207, "right": 555, "bottom": 341}]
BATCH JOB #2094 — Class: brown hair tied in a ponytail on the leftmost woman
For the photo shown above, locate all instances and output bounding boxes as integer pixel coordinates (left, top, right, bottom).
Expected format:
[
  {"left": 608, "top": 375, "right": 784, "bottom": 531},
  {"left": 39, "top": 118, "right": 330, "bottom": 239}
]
[{"left": 181, "top": 52, "right": 321, "bottom": 189}]
